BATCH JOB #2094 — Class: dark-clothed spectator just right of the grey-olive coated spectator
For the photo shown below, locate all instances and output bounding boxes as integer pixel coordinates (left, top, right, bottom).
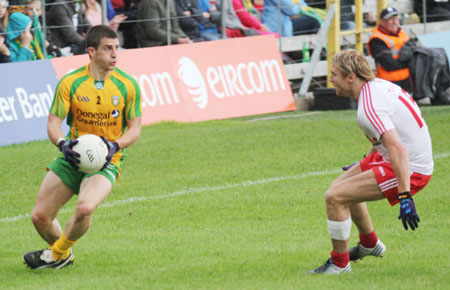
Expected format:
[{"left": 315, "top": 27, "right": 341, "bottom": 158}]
[{"left": 175, "top": 0, "right": 220, "bottom": 42}]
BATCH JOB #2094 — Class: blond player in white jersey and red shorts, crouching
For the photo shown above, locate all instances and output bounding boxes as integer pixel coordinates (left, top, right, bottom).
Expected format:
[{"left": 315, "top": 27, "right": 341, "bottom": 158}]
[{"left": 308, "top": 50, "right": 434, "bottom": 274}]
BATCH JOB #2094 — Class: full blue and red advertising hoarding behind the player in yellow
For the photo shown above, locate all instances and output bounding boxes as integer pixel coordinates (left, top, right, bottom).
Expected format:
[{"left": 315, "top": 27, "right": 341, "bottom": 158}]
[{"left": 0, "top": 36, "right": 296, "bottom": 146}]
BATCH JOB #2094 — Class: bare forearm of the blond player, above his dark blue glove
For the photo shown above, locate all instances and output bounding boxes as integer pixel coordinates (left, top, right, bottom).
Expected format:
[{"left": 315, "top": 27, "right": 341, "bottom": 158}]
[{"left": 381, "top": 129, "right": 410, "bottom": 192}]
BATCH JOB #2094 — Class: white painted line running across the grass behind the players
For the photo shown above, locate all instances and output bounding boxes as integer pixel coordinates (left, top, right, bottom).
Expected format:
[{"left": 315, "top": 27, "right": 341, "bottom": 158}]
[{"left": 0, "top": 153, "right": 450, "bottom": 222}]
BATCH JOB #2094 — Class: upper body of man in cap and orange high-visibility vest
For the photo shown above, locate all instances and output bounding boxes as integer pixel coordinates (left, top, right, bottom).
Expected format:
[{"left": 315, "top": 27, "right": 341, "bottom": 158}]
[{"left": 367, "top": 7, "right": 412, "bottom": 92}]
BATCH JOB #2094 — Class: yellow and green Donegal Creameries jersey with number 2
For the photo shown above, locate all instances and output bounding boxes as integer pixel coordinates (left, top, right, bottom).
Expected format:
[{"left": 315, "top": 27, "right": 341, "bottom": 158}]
[{"left": 50, "top": 65, "right": 142, "bottom": 165}]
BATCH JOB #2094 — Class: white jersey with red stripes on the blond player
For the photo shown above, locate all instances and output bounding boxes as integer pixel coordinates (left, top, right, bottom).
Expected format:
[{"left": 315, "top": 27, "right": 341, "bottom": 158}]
[{"left": 357, "top": 78, "right": 434, "bottom": 175}]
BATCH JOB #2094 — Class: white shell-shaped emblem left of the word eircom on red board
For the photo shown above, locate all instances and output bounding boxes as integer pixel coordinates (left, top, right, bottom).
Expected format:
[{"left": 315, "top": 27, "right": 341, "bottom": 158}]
[{"left": 178, "top": 57, "right": 208, "bottom": 109}]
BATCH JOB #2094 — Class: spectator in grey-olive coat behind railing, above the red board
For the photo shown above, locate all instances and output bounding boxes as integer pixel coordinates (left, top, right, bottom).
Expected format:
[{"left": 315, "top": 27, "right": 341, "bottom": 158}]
[{"left": 137, "top": 0, "right": 192, "bottom": 47}]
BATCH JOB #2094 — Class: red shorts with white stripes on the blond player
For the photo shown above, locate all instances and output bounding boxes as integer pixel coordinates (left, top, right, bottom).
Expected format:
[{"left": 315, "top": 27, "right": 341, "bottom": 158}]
[{"left": 359, "top": 151, "right": 431, "bottom": 205}]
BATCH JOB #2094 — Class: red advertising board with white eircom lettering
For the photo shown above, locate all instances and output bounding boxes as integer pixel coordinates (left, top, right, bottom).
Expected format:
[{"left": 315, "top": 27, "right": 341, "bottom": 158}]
[{"left": 52, "top": 36, "right": 295, "bottom": 124}]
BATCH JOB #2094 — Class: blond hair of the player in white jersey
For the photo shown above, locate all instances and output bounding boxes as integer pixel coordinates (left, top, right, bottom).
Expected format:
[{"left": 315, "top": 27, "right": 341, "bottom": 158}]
[{"left": 331, "top": 49, "right": 375, "bottom": 81}]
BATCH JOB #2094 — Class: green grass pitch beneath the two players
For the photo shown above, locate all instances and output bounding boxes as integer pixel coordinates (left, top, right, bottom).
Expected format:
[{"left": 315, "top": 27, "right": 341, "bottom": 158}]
[{"left": 0, "top": 106, "right": 450, "bottom": 289}]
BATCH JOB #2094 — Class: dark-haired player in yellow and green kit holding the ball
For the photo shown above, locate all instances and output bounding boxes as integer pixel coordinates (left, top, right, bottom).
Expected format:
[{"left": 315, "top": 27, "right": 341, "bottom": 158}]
[{"left": 23, "top": 25, "right": 142, "bottom": 269}]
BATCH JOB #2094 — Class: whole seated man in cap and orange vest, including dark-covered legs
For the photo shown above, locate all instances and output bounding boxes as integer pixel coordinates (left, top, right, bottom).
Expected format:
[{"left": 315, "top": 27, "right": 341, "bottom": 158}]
[{"left": 368, "top": 7, "right": 450, "bottom": 105}]
